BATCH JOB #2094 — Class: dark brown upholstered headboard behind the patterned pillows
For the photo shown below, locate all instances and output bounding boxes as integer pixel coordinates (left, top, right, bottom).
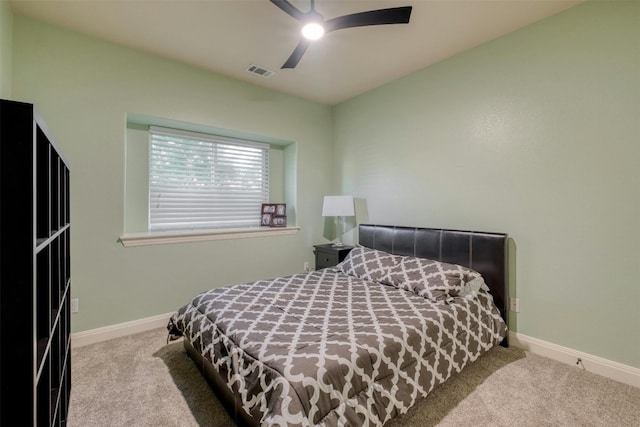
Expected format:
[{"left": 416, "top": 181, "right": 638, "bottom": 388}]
[{"left": 358, "top": 224, "right": 509, "bottom": 338}]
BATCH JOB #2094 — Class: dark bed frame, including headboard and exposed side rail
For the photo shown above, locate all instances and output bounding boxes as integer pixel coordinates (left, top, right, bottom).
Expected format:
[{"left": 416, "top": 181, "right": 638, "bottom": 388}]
[{"left": 183, "top": 224, "right": 509, "bottom": 426}]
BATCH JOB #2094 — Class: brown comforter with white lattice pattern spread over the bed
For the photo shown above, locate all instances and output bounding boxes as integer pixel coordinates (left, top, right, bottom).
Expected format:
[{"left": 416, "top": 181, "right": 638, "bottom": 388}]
[{"left": 170, "top": 269, "right": 506, "bottom": 426}]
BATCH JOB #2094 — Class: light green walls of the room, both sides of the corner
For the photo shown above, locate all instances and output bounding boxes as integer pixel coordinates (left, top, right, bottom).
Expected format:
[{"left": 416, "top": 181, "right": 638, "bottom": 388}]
[{"left": 10, "top": 1, "right": 640, "bottom": 367}]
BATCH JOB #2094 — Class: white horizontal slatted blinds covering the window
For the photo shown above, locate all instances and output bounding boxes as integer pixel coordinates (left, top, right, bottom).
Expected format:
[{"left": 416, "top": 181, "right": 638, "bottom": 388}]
[{"left": 149, "top": 126, "right": 269, "bottom": 231}]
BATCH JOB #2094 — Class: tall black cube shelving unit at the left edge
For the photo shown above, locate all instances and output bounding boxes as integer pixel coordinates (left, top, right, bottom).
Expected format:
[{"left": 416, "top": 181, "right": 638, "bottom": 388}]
[{"left": 0, "top": 100, "right": 71, "bottom": 426}]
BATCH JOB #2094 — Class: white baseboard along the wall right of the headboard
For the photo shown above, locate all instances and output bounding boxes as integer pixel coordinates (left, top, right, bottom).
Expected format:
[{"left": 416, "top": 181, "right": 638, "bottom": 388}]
[{"left": 509, "top": 332, "right": 640, "bottom": 388}]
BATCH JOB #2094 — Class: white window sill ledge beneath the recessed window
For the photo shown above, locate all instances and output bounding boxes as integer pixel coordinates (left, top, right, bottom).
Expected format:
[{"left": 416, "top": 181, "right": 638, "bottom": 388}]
[{"left": 118, "top": 227, "right": 300, "bottom": 248}]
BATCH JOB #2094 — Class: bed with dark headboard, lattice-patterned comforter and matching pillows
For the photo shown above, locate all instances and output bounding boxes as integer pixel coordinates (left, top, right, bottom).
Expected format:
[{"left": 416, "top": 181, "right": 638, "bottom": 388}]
[{"left": 168, "top": 224, "right": 508, "bottom": 426}]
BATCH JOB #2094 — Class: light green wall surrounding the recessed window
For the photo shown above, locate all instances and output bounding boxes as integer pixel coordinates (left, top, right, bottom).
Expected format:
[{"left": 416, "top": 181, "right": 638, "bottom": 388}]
[{"left": 13, "top": 15, "right": 333, "bottom": 331}]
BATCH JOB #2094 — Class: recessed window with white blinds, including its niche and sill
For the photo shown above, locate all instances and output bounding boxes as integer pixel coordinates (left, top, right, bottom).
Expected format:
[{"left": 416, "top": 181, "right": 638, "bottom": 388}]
[{"left": 119, "top": 113, "right": 299, "bottom": 247}]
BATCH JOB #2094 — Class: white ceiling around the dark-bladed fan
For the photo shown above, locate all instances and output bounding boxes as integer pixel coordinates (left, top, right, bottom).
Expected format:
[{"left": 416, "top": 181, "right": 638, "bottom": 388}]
[{"left": 11, "top": 0, "right": 581, "bottom": 105}]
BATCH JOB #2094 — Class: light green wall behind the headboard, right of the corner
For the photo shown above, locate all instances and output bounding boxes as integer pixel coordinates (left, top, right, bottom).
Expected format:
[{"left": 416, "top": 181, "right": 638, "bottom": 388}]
[{"left": 334, "top": 2, "right": 640, "bottom": 367}]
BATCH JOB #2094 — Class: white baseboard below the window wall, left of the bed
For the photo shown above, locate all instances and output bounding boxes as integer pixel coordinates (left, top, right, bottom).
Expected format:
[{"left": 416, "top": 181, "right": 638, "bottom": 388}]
[{"left": 71, "top": 312, "right": 173, "bottom": 348}]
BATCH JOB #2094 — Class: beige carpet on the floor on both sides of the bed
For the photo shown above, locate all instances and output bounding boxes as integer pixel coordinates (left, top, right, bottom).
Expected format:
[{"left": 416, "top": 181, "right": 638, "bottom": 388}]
[{"left": 67, "top": 329, "right": 640, "bottom": 427}]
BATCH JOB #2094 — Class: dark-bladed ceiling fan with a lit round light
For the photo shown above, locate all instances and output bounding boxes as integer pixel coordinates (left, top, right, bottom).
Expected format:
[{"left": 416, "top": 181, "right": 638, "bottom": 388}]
[{"left": 269, "top": 0, "right": 412, "bottom": 68}]
